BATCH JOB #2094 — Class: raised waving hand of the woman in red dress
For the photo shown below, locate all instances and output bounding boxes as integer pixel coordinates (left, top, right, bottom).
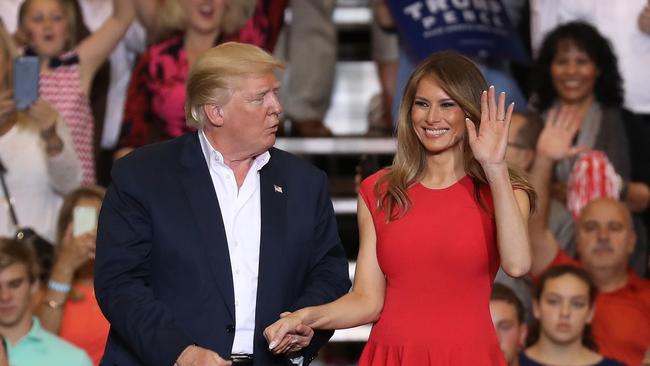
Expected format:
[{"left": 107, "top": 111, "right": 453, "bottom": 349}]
[{"left": 465, "top": 86, "right": 514, "bottom": 168}]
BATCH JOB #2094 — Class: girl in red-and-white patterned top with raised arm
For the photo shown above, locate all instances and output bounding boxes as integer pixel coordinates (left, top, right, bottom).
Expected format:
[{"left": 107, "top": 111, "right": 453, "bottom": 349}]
[{"left": 18, "top": 0, "right": 135, "bottom": 184}]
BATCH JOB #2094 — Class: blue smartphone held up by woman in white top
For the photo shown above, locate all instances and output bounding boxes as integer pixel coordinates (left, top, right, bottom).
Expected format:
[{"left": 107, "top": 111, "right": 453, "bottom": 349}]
[{"left": 13, "top": 56, "right": 40, "bottom": 110}]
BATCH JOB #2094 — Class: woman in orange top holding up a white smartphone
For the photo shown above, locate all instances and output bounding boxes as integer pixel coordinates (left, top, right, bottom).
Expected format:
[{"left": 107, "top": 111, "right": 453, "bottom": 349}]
[{"left": 37, "top": 186, "right": 109, "bottom": 365}]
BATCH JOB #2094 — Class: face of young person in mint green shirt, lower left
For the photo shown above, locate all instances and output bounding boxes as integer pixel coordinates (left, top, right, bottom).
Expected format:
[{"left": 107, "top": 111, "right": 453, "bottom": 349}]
[{"left": 0, "top": 263, "right": 37, "bottom": 328}]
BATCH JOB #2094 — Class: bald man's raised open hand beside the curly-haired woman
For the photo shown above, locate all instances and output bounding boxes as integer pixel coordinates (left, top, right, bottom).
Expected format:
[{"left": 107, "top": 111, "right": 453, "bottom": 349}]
[{"left": 537, "top": 106, "right": 586, "bottom": 161}]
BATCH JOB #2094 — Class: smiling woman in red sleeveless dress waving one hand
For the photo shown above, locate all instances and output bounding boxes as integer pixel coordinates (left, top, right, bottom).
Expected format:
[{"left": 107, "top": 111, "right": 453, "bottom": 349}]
[{"left": 265, "top": 52, "right": 535, "bottom": 365}]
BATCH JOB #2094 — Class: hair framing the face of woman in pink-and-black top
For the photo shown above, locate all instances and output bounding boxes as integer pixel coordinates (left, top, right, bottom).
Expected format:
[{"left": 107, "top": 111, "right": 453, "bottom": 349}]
[{"left": 154, "top": 0, "right": 257, "bottom": 41}]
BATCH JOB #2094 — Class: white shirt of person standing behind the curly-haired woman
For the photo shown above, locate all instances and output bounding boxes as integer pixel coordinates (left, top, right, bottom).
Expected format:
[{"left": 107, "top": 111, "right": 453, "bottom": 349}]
[{"left": 530, "top": 0, "right": 650, "bottom": 114}]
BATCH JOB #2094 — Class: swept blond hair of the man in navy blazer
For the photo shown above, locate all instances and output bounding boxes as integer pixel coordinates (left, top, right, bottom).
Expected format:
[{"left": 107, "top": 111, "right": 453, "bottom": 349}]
[{"left": 185, "top": 42, "right": 284, "bottom": 129}]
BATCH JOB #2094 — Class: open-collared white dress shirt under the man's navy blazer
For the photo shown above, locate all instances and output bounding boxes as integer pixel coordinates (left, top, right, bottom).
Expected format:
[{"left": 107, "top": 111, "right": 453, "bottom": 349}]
[{"left": 198, "top": 130, "right": 271, "bottom": 354}]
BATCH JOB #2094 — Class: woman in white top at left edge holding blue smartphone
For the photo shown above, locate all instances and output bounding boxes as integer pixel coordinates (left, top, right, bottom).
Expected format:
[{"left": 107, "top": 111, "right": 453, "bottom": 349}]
[{"left": 0, "top": 19, "right": 81, "bottom": 241}]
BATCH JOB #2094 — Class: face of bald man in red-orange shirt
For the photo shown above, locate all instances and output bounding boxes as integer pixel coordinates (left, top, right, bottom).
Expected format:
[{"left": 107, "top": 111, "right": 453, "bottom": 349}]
[{"left": 576, "top": 199, "right": 636, "bottom": 270}]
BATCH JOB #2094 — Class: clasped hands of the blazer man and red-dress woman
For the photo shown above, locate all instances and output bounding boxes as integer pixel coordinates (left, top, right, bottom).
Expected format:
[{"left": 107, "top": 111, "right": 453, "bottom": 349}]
[{"left": 264, "top": 312, "right": 314, "bottom": 354}]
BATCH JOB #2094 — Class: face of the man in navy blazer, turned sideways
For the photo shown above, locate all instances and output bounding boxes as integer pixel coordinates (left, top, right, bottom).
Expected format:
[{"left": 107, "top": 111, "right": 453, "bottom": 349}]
[{"left": 218, "top": 73, "right": 282, "bottom": 156}]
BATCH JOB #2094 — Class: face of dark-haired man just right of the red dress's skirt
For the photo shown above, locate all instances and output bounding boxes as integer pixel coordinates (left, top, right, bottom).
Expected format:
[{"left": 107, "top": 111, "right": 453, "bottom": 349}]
[{"left": 490, "top": 300, "right": 528, "bottom": 365}]
